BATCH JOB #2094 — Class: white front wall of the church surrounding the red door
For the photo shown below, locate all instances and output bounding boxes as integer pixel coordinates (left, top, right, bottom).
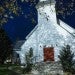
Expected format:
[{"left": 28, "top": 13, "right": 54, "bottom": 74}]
[{"left": 21, "top": 4, "right": 75, "bottom": 63}]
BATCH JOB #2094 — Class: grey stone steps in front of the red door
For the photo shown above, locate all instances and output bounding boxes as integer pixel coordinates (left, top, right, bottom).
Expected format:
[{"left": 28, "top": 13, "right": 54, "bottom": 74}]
[{"left": 33, "top": 62, "right": 63, "bottom": 75}]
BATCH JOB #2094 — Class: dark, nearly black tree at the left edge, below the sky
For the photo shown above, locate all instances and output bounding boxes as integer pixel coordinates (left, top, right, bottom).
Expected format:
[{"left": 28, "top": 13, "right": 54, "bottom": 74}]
[{"left": 0, "top": 28, "right": 12, "bottom": 64}]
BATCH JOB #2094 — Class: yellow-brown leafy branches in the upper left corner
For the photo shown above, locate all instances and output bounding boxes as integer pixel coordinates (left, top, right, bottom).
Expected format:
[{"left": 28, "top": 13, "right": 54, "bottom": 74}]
[{"left": 0, "top": 0, "right": 20, "bottom": 25}]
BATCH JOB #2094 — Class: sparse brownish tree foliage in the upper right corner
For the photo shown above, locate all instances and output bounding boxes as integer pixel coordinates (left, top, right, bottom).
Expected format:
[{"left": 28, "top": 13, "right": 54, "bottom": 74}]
[{"left": 56, "top": 0, "right": 75, "bottom": 18}]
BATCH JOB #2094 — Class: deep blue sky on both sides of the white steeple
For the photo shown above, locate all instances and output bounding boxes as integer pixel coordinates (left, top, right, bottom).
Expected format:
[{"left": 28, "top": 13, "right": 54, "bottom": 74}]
[{"left": 3, "top": 0, "right": 75, "bottom": 42}]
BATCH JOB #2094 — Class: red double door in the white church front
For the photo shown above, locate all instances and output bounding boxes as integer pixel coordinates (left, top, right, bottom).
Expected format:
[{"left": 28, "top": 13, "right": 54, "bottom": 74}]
[{"left": 44, "top": 47, "right": 54, "bottom": 61}]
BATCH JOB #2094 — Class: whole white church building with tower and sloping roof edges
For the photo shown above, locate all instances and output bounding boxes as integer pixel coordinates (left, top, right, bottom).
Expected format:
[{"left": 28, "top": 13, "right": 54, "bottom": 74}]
[{"left": 17, "top": 0, "right": 75, "bottom": 63}]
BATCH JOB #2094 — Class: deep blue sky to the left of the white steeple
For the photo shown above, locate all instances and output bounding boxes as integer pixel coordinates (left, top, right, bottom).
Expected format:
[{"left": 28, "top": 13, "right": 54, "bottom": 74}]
[{"left": 3, "top": 1, "right": 38, "bottom": 42}]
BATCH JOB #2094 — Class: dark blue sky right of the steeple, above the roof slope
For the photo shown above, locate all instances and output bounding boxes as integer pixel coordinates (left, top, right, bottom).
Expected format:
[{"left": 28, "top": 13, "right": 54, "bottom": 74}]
[{"left": 56, "top": 0, "right": 75, "bottom": 28}]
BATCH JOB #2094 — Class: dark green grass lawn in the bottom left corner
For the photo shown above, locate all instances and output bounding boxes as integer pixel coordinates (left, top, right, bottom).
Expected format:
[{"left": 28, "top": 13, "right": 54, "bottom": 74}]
[{"left": 0, "top": 64, "right": 21, "bottom": 75}]
